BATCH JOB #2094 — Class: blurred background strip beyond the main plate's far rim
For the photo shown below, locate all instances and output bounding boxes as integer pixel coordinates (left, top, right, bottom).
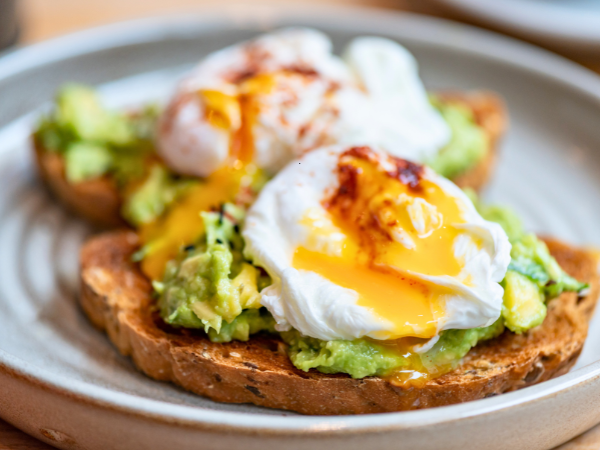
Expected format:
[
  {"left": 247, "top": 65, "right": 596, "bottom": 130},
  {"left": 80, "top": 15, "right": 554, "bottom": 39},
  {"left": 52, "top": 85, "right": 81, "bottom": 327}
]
[{"left": 7, "top": 0, "right": 600, "bottom": 72}]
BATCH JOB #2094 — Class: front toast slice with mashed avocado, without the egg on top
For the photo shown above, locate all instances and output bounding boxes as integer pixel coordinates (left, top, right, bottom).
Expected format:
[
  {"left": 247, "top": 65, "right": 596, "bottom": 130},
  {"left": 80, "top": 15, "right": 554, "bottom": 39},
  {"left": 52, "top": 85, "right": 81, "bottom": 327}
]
[{"left": 76, "top": 142, "right": 598, "bottom": 414}]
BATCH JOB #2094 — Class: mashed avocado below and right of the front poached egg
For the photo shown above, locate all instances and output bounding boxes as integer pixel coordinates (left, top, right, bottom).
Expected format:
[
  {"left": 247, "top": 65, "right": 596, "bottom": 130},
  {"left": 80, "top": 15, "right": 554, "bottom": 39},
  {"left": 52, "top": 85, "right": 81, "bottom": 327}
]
[{"left": 282, "top": 199, "right": 586, "bottom": 378}]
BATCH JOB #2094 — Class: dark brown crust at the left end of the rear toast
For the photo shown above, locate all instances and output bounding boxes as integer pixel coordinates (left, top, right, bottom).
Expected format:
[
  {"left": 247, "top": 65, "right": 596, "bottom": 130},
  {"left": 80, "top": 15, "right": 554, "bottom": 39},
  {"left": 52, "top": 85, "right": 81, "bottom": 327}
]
[{"left": 32, "top": 138, "right": 125, "bottom": 228}]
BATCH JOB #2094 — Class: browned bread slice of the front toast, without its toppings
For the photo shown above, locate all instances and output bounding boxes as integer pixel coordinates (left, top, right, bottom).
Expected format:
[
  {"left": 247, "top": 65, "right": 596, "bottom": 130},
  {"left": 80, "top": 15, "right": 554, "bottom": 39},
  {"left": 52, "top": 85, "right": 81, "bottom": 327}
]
[{"left": 81, "top": 231, "right": 598, "bottom": 414}]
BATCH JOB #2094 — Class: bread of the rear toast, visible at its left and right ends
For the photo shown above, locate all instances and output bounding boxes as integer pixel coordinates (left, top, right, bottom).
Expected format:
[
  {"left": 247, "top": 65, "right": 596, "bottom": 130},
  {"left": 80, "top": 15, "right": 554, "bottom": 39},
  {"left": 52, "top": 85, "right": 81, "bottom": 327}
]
[{"left": 33, "top": 92, "right": 507, "bottom": 228}]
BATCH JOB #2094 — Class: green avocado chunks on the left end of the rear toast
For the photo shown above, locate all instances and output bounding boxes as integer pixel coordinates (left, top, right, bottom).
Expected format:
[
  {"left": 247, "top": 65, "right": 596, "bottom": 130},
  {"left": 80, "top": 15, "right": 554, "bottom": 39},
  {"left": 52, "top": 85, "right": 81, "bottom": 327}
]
[{"left": 34, "top": 84, "right": 193, "bottom": 226}]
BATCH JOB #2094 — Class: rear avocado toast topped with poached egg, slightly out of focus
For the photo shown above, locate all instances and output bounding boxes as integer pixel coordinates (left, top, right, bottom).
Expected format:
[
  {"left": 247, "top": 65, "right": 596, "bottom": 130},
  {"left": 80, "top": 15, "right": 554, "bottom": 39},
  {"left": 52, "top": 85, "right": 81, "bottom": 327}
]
[{"left": 34, "top": 29, "right": 507, "bottom": 227}]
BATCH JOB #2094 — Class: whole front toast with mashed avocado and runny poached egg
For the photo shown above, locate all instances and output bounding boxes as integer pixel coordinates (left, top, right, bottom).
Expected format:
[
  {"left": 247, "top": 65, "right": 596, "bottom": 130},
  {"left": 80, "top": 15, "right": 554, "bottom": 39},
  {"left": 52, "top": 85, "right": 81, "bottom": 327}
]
[{"left": 81, "top": 147, "right": 598, "bottom": 414}]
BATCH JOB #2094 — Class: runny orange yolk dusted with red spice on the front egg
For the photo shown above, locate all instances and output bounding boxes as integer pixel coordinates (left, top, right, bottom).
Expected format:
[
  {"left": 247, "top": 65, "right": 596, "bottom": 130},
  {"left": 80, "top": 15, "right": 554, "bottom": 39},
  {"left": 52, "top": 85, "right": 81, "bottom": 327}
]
[{"left": 292, "top": 148, "right": 464, "bottom": 339}]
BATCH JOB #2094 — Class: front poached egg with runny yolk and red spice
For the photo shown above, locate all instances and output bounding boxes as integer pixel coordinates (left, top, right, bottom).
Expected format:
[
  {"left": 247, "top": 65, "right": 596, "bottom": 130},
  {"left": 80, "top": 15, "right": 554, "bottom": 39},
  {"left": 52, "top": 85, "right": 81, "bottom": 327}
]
[{"left": 242, "top": 145, "right": 511, "bottom": 342}]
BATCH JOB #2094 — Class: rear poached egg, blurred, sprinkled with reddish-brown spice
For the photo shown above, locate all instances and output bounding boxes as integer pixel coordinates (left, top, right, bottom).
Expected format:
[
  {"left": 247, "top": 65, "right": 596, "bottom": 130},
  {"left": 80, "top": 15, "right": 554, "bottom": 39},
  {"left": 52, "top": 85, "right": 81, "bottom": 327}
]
[{"left": 158, "top": 28, "right": 450, "bottom": 177}]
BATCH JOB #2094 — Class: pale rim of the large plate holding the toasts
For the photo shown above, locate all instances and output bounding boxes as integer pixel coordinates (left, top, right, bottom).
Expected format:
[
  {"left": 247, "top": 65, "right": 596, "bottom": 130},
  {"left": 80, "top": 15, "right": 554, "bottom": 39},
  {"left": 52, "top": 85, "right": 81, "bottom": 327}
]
[{"left": 0, "top": 0, "right": 600, "bottom": 435}]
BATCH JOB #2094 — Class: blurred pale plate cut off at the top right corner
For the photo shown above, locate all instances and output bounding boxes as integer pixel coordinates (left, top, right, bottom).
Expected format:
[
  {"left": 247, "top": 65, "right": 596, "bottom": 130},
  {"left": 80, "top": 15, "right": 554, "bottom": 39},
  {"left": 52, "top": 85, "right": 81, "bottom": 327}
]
[{"left": 438, "top": 0, "right": 600, "bottom": 50}]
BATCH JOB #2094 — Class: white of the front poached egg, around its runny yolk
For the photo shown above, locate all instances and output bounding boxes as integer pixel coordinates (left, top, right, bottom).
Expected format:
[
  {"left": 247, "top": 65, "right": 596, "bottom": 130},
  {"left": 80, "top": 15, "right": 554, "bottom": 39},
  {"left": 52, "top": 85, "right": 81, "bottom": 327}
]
[{"left": 242, "top": 145, "right": 511, "bottom": 340}]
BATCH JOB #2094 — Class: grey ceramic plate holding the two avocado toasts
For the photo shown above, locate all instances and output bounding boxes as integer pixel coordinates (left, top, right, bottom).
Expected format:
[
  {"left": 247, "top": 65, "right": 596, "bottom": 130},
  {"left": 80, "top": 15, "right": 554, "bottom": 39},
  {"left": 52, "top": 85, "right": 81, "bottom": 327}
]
[{"left": 0, "top": 5, "right": 600, "bottom": 450}]
